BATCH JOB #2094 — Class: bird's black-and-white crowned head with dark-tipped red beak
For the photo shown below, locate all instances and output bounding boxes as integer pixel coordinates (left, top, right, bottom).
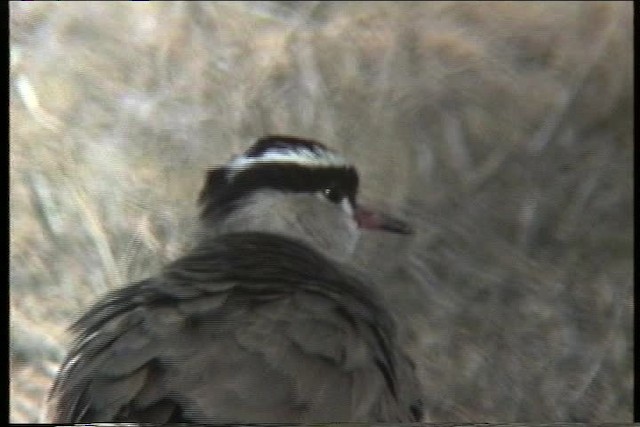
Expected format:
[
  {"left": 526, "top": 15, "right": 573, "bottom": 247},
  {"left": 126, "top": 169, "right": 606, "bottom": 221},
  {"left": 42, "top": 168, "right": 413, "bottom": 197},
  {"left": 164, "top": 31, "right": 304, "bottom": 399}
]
[{"left": 199, "top": 135, "right": 410, "bottom": 259}]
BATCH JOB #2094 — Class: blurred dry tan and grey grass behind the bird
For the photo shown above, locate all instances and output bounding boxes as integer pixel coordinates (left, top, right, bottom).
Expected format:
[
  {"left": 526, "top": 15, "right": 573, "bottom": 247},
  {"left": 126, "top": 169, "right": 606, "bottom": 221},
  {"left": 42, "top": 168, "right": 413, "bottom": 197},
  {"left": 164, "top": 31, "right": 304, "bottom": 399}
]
[{"left": 10, "top": 1, "right": 633, "bottom": 422}]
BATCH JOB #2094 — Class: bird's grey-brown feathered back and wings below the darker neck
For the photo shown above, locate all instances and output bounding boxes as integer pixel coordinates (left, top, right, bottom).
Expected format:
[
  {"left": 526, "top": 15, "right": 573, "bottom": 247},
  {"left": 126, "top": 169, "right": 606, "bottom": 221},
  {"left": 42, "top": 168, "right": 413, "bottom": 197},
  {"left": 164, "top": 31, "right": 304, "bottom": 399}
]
[{"left": 51, "top": 279, "right": 413, "bottom": 423}]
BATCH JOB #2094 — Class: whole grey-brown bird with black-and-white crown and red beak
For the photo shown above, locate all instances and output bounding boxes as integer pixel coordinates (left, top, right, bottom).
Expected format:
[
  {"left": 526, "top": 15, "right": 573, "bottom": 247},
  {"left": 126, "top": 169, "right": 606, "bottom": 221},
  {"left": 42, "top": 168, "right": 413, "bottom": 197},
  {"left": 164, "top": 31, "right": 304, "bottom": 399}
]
[{"left": 47, "top": 135, "right": 423, "bottom": 423}]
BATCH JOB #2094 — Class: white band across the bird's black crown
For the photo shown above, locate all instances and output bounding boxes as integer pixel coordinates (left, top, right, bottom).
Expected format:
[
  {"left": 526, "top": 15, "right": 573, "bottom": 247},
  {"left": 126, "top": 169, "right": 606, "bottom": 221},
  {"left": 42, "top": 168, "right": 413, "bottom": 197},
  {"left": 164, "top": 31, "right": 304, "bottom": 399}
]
[{"left": 227, "top": 147, "right": 350, "bottom": 178}]
